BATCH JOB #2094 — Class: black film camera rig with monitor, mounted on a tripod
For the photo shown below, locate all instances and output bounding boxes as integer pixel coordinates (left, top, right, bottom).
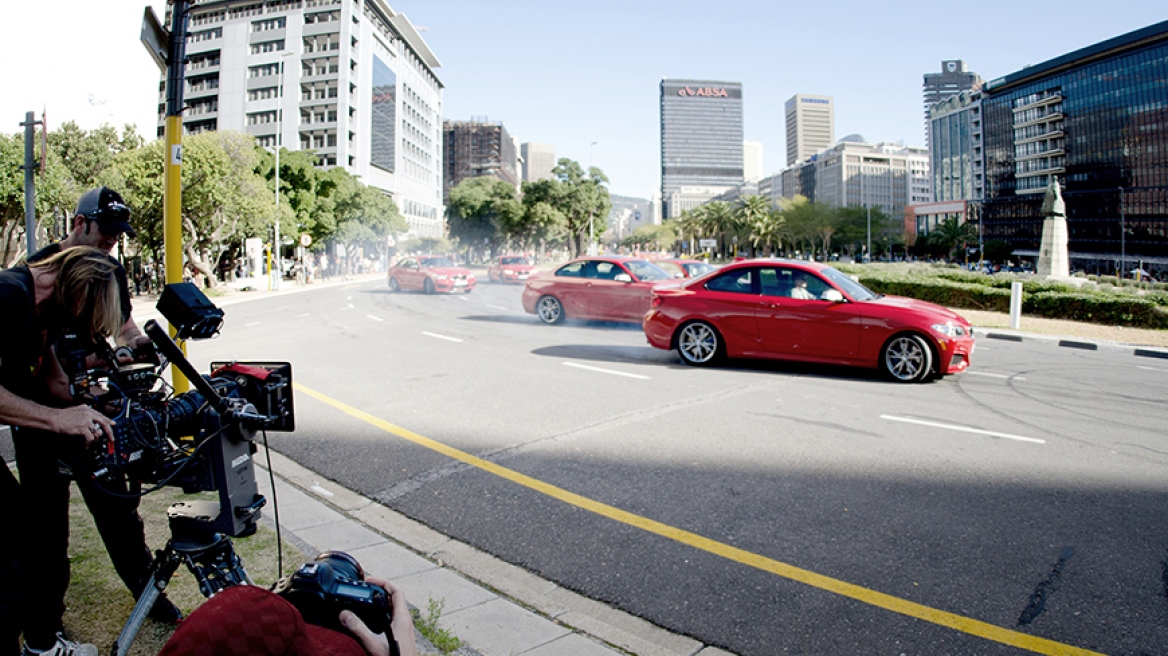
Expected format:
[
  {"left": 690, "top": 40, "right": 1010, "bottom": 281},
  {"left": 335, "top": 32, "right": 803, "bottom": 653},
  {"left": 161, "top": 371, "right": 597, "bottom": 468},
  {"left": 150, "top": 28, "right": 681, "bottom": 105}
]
[{"left": 57, "top": 282, "right": 296, "bottom": 655}]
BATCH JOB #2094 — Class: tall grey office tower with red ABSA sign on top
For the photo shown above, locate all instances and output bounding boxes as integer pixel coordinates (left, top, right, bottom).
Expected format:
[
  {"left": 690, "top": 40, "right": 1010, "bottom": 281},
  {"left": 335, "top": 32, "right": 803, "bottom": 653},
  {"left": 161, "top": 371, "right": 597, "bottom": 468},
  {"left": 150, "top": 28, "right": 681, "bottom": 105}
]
[{"left": 660, "top": 79, "right": 744, "bottom": 218}]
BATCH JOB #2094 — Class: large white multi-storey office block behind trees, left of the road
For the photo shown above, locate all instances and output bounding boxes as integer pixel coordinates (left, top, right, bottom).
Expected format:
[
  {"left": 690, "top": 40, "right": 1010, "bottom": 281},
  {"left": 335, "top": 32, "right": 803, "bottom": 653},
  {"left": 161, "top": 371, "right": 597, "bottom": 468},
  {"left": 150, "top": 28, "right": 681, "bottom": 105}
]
[{"left": 170, "top": 0, "right": 444, "bottom": 236}]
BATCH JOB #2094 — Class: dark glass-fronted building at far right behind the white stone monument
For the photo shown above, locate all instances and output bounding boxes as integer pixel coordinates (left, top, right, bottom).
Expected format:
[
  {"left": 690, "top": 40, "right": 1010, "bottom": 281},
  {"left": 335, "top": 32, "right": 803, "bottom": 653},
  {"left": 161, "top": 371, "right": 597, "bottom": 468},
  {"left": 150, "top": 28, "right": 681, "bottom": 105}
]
[{"left": 982, "top": 21, "right": 1168, "bottom": 266}]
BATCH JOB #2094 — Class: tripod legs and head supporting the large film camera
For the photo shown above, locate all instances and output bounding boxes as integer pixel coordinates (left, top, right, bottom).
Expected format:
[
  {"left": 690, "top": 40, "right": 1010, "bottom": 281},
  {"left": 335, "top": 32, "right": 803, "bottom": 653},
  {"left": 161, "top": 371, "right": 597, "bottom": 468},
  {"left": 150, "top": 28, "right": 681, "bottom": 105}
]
[{"left": 112, "top": 501, "right": 256, "bottom": 656}]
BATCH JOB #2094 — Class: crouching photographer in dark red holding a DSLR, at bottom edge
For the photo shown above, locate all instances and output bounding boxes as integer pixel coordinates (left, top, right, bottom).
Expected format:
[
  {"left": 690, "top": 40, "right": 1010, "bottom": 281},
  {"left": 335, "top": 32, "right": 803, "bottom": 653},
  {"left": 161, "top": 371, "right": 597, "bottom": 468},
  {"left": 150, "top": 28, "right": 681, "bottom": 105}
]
[{"left": 159, "top": 577, "right": 417, "bottom": 656}]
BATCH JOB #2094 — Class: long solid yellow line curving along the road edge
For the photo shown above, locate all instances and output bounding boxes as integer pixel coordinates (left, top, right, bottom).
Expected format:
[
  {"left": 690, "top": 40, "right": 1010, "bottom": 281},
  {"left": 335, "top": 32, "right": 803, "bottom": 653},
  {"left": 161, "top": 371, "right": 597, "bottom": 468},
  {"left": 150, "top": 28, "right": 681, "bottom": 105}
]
[{"left": 294, "top": 383, "right": 1103, "bottom": 656}]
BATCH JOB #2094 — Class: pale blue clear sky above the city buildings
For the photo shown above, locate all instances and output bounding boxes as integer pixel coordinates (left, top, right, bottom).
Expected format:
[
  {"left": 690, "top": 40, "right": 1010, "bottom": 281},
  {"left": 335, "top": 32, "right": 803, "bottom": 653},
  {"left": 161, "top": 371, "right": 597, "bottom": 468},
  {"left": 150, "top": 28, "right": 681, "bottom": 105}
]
[{"left": 0, "top": 0, "right": 1168, "bottom": 197}]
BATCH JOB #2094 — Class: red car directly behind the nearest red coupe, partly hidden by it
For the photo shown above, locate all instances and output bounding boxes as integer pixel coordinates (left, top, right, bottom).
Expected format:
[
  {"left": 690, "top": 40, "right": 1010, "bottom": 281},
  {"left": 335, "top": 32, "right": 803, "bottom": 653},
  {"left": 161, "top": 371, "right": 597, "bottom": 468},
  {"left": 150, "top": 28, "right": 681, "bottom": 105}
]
[{"left": 523, "top": 257, "right": 673, "bottom": 323}]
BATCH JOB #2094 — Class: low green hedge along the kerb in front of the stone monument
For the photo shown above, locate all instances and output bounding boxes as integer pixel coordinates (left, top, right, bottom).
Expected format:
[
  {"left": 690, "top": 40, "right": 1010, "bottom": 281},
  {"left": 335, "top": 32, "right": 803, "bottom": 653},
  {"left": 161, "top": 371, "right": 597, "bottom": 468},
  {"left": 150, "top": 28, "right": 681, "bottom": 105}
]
[{"left": 840, "top": 265, "right": 1168, "bottom": 329}]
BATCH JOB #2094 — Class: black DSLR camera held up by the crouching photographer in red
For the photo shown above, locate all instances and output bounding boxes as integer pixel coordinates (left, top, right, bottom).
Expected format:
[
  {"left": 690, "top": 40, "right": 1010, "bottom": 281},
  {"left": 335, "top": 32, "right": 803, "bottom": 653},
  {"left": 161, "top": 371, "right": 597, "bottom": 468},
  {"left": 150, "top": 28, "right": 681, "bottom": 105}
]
[{"left": 272, "top": 551, "right": 395, "bottom": 649}]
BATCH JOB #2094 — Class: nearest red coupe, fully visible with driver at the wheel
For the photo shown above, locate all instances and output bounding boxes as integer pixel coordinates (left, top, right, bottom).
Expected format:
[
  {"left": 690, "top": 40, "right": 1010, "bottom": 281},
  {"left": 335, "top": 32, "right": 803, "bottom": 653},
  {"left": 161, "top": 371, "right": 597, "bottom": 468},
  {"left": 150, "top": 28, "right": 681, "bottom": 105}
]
[{"left": 642, "top": 259, "right": 974, "bottom": 383}]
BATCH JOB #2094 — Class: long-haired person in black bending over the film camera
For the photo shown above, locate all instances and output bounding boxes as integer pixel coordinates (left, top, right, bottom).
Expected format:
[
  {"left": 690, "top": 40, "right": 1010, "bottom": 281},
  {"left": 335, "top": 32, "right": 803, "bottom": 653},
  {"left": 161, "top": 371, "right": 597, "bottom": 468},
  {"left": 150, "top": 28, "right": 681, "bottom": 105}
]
[{"left": 0, "top": 246, "right": 173, "bottom": 656}]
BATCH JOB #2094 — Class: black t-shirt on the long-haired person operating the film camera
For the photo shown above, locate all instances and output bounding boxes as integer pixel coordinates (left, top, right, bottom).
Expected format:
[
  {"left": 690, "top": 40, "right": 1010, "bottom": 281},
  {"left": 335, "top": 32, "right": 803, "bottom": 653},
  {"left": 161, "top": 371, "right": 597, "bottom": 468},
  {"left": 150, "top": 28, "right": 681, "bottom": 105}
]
[{"left": 0, "top": 261, "right": 46, "bottom": 400}]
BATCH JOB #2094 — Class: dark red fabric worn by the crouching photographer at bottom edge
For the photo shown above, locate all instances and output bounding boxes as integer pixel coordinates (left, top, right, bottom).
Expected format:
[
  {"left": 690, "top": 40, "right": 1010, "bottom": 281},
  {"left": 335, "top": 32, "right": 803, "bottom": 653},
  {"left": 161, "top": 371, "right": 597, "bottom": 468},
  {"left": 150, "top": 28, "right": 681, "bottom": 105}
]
[{"left": 159, "top": 586, "right": 366, "bottom": 656}]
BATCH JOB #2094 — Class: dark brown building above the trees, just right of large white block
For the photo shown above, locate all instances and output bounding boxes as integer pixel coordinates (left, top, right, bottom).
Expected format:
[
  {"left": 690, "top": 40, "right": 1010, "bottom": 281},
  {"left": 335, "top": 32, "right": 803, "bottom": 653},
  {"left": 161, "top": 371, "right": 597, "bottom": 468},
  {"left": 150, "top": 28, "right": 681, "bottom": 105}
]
[{"left": 443, "top": 119, "right": 520, "bottom": 198}]
